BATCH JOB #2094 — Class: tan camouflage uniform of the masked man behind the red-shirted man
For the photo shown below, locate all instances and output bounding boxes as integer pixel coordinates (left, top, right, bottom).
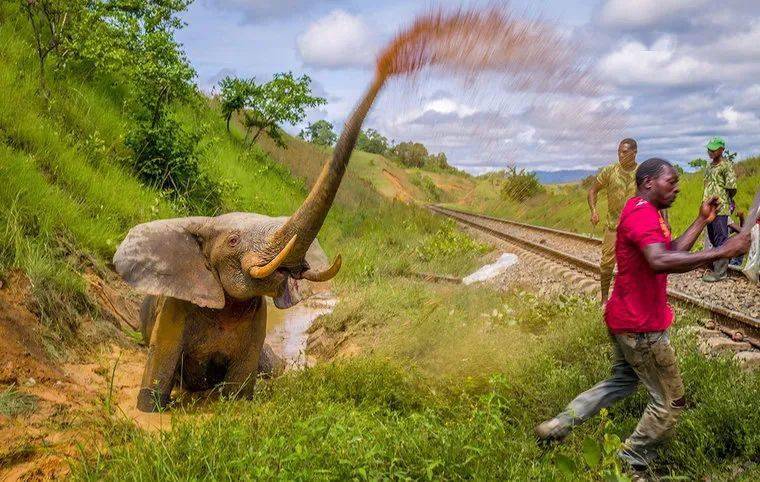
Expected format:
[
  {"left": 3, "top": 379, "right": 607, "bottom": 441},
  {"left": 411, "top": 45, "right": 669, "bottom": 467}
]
[{"left": 596, "top": 162, "right": 636, "bottom": 293}]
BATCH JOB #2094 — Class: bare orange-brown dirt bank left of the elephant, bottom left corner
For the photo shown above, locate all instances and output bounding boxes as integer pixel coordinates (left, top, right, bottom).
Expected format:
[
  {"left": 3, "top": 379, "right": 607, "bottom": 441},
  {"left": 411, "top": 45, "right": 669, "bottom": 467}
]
[{"left": 0, "top": 271, "right": 145, "bottom": 480}]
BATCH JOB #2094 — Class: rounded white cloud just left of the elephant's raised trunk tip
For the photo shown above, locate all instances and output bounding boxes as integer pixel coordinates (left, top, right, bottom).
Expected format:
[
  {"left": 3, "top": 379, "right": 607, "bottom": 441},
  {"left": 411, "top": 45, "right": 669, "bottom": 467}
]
[{"left": 296, "top": 10, "right": 377, "bottom": 69}]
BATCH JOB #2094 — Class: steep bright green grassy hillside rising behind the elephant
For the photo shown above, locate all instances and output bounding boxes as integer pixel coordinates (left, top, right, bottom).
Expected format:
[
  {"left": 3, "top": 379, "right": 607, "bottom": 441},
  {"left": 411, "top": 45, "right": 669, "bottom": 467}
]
[{"left": 0, "top": 7, "right": 474, "bottom": 346}]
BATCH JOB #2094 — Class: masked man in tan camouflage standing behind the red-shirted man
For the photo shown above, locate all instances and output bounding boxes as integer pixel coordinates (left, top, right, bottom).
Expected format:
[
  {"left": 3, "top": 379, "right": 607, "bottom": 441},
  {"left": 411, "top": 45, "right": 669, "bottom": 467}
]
[{"left": 588, "top": 139, "right": 638, "bottom": 303}]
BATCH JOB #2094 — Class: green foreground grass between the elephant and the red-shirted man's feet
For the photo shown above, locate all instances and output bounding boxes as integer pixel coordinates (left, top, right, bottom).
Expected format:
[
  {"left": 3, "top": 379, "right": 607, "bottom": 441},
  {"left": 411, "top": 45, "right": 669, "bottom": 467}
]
[{"left": 75, "top": 292, "right": 760, "bottom": 480}]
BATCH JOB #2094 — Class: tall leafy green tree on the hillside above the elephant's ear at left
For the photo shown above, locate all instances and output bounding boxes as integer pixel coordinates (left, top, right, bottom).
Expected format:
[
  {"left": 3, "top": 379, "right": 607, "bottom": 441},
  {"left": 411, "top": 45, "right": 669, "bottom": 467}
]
[{"left": 65, "top": 0, "right": 222, "bottom": 208}]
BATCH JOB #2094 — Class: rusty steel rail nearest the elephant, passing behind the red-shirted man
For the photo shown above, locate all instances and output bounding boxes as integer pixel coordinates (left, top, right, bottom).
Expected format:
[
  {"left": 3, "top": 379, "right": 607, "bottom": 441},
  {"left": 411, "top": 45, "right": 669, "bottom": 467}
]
[{"left": 428, "top": 205, "right": 760, "bottom": 348}]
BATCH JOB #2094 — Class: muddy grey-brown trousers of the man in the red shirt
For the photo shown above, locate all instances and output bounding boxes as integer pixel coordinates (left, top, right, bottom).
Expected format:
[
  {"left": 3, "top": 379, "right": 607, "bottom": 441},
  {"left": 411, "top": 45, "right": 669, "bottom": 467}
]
[{"left": 557, "top": 331, "right": 685, "bottom": 466}]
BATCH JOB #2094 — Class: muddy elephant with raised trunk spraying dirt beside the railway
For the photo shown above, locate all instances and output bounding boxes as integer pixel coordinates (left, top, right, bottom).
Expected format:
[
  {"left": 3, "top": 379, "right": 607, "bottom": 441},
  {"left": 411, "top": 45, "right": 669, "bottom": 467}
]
[{"left": 113, "top": 80, "right": 383, "bottom": 411}]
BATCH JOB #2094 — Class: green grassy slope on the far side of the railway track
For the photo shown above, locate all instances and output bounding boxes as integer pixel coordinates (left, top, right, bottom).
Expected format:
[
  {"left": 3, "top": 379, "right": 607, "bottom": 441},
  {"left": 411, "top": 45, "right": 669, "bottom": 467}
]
[{"left": 454, "top": 157, "right": 760, "bottom": 236}]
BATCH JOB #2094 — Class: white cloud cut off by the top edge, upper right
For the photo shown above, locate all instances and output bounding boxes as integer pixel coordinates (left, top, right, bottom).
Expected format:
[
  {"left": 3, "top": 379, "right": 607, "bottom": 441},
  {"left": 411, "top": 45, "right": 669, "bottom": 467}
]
[{"left": 599, "top": 0, "right": 708, "bottom": 29}]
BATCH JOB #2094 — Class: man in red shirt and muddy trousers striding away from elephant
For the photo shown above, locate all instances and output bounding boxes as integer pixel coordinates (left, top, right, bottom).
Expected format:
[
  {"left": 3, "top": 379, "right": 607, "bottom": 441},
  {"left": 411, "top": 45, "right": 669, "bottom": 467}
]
[{"left": 536, "top": 158, "right": 750, "bottom": 470}]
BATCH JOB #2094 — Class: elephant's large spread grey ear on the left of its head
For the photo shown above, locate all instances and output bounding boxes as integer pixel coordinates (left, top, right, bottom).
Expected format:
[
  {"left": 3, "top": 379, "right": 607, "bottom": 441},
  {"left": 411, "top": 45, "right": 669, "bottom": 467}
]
[{"left": 113, "top": 217, "right": 224, "bottom": 309}]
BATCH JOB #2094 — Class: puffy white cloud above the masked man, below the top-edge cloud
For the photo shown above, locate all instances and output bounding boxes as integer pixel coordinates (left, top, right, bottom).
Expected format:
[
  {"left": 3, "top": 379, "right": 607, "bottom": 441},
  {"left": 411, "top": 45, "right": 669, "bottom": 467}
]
[{"left": 599, "top": 36, "right": 717, "bottom": 86}]
